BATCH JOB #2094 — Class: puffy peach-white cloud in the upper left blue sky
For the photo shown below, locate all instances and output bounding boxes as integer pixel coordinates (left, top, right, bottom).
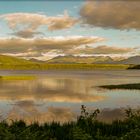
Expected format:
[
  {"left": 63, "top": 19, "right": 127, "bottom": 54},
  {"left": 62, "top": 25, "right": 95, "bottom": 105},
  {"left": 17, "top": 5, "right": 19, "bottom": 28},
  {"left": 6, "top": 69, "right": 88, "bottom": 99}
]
[{"left": 0, "top": 12, "right": 78, "bottom": 38}]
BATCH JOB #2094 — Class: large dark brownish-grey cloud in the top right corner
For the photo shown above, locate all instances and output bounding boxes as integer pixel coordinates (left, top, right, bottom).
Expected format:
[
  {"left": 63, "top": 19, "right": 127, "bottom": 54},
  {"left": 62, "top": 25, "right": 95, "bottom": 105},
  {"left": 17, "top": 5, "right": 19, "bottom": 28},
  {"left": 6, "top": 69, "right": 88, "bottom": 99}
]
[{"left": 80, "top": 0, "right": 140, "bottom": 30}]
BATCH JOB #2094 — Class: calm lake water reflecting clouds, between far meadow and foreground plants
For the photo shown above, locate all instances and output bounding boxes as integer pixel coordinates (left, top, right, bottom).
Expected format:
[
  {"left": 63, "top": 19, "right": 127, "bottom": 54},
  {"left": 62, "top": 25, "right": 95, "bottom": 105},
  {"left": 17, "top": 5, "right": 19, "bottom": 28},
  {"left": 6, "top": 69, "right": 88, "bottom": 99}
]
[{"left": 0, "top": 70, "right": 140, "bottom": 123}]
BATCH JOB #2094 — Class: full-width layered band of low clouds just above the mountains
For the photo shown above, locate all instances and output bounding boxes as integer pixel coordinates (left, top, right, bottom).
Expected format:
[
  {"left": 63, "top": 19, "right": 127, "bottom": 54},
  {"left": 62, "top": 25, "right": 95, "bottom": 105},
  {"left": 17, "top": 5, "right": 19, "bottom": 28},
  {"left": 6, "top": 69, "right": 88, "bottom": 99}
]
[{"left": 0, "top": 36, "right": 140, "bottom": 61}]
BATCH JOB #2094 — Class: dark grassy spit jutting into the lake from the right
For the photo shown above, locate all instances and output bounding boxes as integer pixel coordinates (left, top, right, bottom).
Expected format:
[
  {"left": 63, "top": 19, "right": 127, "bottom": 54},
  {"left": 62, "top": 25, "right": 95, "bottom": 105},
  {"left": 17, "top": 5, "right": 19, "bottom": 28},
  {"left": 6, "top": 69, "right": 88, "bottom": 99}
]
[{"left": 100, "top": 83, "right": 140, "bottom": 90}]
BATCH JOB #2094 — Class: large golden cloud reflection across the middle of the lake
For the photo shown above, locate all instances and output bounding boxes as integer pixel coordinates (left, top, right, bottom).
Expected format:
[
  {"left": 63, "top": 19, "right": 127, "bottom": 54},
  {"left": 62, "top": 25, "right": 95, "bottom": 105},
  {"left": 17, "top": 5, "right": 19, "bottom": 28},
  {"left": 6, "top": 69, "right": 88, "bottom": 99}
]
[{"left": 0, "top": 77, "right": 105, "bottom": 103}]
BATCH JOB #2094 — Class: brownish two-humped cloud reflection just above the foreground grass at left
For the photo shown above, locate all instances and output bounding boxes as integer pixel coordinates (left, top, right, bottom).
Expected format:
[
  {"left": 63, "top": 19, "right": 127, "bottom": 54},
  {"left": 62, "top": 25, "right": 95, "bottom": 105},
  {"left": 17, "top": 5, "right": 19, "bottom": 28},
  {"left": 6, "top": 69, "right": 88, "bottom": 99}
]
[{"left": 7, "top": 101, "right": 76, "bottom": 123}]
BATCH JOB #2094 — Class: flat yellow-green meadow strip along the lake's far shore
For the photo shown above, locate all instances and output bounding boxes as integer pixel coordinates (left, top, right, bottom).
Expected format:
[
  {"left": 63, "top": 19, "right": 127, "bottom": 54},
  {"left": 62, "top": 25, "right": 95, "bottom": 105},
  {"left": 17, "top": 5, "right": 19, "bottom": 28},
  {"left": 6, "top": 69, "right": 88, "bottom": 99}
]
[{"left": 0, "top": 63, "right": 129, "bottom": 70}]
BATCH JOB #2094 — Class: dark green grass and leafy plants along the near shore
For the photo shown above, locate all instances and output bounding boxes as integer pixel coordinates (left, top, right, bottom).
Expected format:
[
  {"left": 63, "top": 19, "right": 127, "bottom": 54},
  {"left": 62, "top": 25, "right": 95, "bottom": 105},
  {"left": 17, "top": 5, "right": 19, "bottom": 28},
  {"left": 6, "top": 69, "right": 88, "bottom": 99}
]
[{"left": 0, "top": 105, "right": 140, "bottom": 140}]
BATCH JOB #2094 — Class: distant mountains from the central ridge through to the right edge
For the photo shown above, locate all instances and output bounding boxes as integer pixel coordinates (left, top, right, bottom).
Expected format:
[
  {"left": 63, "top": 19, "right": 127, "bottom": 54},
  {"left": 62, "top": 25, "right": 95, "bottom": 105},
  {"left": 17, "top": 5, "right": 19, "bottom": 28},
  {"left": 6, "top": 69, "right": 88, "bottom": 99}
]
[{"left": 46, "top": 55, "right": 140, "bottom": 65}]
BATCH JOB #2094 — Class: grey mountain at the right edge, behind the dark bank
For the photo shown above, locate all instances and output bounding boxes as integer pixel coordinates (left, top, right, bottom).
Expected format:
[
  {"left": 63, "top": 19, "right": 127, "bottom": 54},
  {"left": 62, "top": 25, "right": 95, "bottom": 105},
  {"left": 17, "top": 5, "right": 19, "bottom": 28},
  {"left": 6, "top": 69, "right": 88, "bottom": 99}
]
[{"left": 117, "top": 56, "right": 140, "bottom": 65}]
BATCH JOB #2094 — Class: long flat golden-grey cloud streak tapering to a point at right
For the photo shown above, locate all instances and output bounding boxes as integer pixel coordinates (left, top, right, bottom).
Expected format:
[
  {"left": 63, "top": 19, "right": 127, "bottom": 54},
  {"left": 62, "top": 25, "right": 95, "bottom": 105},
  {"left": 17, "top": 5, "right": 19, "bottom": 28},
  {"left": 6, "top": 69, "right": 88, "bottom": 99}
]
[{"left": 0, "top": 36, "right": 104, "bottom": 53}]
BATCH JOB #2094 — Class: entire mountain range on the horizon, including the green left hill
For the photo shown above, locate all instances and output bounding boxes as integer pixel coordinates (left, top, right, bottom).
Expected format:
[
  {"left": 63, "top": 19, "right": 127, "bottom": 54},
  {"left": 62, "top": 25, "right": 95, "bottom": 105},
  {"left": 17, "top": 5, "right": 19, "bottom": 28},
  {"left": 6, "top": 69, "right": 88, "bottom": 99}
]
[{"left": 0, "top": 55, "right": 140, "bottom": 65}]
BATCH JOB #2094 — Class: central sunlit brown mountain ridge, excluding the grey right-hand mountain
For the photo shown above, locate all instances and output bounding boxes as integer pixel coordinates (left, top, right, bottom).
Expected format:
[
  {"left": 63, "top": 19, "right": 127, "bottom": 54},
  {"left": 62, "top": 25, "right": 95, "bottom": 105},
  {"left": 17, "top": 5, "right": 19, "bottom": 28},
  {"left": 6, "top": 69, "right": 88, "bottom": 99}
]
[{"left": 47, "top": 55, "right": 114, "bottom": 64}]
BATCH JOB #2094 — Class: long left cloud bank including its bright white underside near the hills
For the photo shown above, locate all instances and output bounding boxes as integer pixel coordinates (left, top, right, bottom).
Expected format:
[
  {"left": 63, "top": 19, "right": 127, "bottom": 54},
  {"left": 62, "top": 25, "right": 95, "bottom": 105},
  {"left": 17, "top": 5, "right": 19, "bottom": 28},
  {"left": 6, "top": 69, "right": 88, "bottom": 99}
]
[{"left": 0, "top": 36, "right": 104, "bottom": 60}]
